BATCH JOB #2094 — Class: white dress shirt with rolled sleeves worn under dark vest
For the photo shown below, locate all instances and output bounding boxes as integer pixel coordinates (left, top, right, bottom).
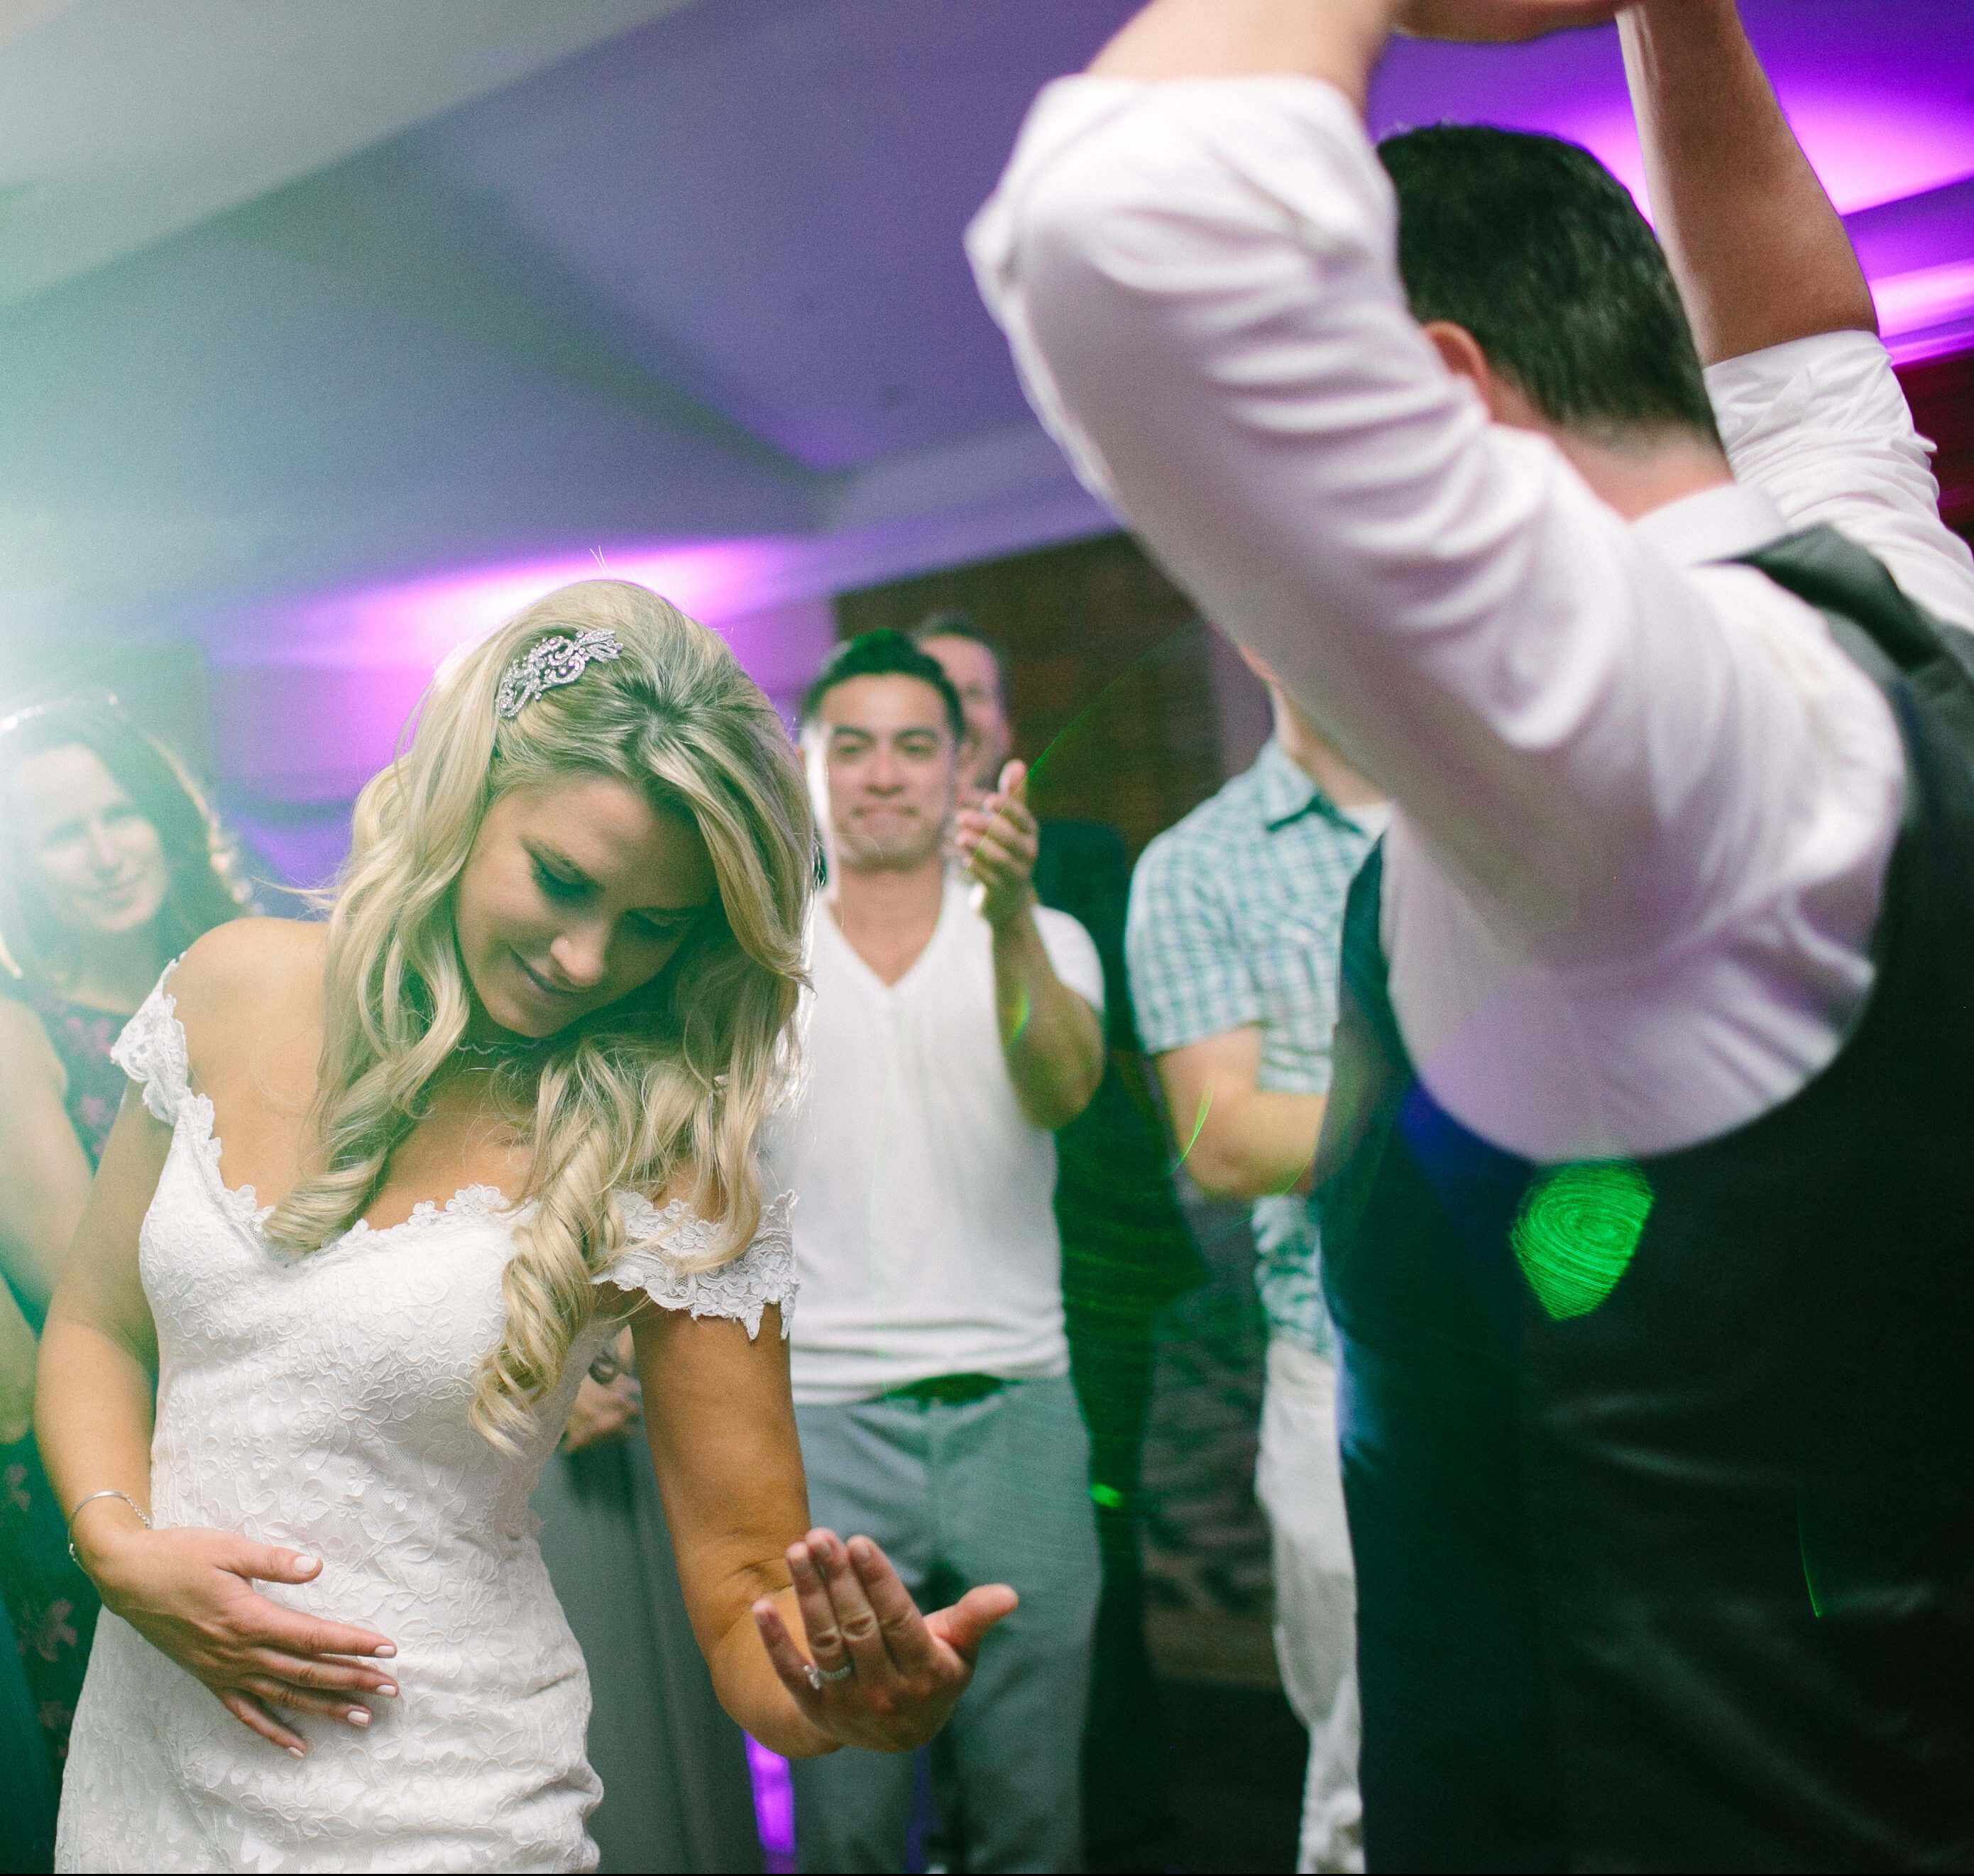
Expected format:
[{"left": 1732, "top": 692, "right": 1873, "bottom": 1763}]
[{"left": 969, "top": 77, "right": 1974, "bottom": 1161}]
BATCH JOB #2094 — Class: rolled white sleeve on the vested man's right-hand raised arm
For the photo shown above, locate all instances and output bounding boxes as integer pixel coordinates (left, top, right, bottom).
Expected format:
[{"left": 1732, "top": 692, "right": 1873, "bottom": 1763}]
[{"left": 1708, "top": 331, "right": 1974, "bottom": 630}]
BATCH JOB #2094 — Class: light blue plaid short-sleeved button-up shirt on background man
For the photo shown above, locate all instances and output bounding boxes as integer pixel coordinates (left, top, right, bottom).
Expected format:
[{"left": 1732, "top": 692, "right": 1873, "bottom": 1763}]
[{"left": 1125, "top": 737, "right": 1383, "bottom": 1356}]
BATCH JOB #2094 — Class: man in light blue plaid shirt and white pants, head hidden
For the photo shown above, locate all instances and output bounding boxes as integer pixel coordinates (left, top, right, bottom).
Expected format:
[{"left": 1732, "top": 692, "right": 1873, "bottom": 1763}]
[{"left": 1125, "top": 659, "right": 1390, "bottom": 1870}]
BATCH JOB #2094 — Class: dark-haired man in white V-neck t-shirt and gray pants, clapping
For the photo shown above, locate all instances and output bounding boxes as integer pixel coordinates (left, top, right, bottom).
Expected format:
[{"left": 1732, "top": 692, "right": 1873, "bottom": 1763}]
[{"left": 766, "top": 632, "right": 1104, "bottom": 1870}]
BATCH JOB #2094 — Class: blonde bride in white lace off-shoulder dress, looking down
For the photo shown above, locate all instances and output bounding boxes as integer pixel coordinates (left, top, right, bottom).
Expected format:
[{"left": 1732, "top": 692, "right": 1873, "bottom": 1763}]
[{"left": 38, "top": 581, "right": 1014, "bottom": 1870}]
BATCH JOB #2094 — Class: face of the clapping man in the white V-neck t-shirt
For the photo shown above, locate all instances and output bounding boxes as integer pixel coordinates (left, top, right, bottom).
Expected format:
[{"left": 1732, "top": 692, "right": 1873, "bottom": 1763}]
[{"left": 807, "top": 675, "right": 960, "bottom": 873}]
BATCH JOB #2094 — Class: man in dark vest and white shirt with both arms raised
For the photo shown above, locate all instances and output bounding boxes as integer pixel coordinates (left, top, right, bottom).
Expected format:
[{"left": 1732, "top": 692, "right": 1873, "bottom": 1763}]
[{"left": 971, "top": 0, "right": 1974, "bottom": 1868}]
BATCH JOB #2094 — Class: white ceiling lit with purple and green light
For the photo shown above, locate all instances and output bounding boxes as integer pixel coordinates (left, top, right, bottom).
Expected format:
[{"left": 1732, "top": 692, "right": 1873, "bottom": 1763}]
[{"left": 0, "top": 0, "right": 1974, "bottom": 683}]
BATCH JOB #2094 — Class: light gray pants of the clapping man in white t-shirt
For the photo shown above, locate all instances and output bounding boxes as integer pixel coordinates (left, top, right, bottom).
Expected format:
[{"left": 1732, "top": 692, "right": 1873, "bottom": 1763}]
[{"left": 789, "top": 1378, "right": 1097, "bottom": 1876}]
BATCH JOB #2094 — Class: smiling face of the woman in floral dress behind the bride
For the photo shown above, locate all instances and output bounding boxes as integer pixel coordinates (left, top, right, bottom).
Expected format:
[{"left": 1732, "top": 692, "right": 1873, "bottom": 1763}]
[{"left": 13, "top": 742, "right": 172, "bottom": 946}]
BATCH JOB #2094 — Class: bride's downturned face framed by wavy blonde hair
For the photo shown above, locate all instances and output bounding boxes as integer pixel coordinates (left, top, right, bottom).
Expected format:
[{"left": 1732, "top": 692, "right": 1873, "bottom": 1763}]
[{"left": 454, "top": 774, "right": 718, "bottom": 1037}]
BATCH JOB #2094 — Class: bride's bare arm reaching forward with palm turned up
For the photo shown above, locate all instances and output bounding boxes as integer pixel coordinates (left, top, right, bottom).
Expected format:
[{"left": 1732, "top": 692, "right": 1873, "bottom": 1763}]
[{"left": 635, "top": 1305, "right": 1014, "bottom": 1757}]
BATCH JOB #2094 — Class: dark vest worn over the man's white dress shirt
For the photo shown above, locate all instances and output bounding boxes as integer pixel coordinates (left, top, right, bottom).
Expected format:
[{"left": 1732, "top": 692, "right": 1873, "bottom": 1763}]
[{"left": 1317, "top": 531, "right": 1974, "bottom": 1870}]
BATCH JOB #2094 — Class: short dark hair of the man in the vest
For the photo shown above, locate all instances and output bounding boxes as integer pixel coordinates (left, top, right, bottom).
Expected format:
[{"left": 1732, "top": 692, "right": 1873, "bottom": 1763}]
[{"left": 1378, "top": 124, "right": 1719, "bottom": 442}]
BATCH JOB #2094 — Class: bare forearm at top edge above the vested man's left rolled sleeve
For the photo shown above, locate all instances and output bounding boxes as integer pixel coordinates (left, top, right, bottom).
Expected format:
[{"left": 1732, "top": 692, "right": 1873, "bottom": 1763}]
[{"left": 1090, "top": 0, "right": 1402, "bottom": 109}]
